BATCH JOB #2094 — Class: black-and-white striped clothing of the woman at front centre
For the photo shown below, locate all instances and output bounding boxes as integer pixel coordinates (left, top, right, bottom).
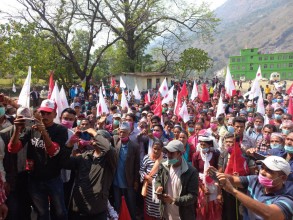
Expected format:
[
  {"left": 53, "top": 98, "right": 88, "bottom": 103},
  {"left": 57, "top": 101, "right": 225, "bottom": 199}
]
[{"left": 139, "top": 154, "right": 161, "bottom": 218}]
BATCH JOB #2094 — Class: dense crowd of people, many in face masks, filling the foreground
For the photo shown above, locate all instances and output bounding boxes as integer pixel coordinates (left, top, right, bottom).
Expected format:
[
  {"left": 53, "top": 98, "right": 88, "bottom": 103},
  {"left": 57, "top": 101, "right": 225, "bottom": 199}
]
[{"left": 0, "top": 78, "right": 293, "bottom": 220}]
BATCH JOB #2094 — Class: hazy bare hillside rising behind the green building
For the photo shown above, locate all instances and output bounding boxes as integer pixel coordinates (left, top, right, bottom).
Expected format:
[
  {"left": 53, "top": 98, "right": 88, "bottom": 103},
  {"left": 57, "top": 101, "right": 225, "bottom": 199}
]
[{"left": 191, "top": 0, "right": 293, "bottom": 72}]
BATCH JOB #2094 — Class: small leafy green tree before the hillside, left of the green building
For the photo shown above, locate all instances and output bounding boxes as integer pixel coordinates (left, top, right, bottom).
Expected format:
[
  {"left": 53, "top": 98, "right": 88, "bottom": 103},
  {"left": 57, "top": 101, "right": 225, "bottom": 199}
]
[{"left": 176, "top": 48, "right": 213, "bottom": 79}]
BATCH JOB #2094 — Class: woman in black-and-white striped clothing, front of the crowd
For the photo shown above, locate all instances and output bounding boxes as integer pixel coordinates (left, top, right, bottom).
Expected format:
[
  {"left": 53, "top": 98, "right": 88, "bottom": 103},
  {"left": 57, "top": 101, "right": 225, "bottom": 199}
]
[{"left": 139, "top": 138, "right": 163, "bottom": 220}]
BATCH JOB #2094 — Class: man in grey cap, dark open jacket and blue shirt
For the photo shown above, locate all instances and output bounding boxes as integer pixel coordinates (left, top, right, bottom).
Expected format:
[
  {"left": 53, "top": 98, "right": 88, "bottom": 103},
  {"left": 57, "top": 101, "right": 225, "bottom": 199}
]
[{"left": 113, "top": 121, "right": 140, "bottom": 219}]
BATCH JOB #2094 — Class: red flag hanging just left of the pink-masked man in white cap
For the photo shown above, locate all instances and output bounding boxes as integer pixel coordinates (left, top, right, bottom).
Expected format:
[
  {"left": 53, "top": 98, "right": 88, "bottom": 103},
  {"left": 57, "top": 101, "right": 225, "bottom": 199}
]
[{"left": 225, "top": 142, "right": 249, "bottom": 176}]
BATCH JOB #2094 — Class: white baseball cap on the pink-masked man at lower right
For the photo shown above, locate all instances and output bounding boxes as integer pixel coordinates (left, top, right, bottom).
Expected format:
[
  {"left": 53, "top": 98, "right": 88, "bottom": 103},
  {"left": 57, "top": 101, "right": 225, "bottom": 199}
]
[{"left": 260, "top": 156, "right": 291, "bottom": 176}]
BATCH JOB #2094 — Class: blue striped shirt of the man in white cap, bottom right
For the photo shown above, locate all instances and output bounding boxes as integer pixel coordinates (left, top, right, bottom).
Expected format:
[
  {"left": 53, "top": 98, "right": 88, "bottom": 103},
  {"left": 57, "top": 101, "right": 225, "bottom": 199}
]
[{"left": 240, "top": 175, "right": 293, "bottom": 220}]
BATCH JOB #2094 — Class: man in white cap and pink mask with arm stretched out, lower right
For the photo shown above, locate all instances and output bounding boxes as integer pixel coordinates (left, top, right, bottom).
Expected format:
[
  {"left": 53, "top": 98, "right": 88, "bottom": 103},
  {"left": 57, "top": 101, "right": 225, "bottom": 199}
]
[{"left": 208, "top": 156, "right": 293, "bottom": 219}]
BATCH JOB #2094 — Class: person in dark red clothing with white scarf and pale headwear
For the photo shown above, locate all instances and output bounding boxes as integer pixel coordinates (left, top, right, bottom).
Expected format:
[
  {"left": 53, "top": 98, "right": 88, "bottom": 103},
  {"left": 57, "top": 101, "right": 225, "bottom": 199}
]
[{"left": 192, "top": 130, "right": 222, "bottom": 220}]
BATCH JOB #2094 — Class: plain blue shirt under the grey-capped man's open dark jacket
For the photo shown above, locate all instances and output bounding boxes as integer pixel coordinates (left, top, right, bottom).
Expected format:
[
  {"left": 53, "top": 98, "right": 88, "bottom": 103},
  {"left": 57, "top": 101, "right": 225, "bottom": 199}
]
[{"left": 114, "top": 144, "right": 128, "bottom": 189}]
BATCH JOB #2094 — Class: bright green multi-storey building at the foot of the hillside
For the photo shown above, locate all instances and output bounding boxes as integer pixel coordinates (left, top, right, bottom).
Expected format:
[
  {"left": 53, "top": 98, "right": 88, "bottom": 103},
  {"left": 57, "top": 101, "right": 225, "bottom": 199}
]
[{"left": 229, "top": 48, "right": 293, "bottom": 80}]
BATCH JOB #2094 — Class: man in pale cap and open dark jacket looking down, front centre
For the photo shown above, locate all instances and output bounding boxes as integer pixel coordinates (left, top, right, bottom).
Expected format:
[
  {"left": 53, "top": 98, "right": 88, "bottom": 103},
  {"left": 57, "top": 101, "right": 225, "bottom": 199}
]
[{"left": 155, "top": 140, "right": 198, "bottom": 220}]
